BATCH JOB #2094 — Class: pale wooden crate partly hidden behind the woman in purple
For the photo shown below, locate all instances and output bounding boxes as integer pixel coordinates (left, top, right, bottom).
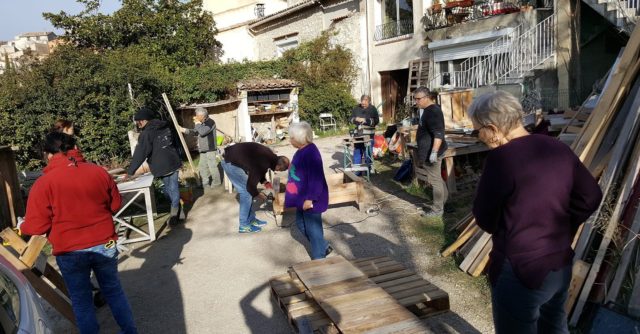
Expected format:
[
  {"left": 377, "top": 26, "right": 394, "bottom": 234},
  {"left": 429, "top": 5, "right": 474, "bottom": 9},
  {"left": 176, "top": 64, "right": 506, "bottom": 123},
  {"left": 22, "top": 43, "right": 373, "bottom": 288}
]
[{"left": 273, "top": 172, "right": 368, "bottom": 215}]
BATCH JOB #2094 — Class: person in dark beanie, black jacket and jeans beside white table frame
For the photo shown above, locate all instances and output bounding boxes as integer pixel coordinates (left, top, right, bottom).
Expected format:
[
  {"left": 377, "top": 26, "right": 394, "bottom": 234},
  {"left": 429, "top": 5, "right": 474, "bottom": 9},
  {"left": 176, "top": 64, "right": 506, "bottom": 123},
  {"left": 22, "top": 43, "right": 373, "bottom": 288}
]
[{"left": 127, "top": 107, "right": 182, "bottom": 225}]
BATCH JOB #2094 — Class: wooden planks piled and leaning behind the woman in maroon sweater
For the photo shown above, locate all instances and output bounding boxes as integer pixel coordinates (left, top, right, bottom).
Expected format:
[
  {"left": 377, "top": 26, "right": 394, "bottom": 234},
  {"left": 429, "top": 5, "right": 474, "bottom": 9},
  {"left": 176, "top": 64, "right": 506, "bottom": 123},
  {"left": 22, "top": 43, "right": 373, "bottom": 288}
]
[{"left": 442, "top": 23, "right": 640, "bottom": 326}]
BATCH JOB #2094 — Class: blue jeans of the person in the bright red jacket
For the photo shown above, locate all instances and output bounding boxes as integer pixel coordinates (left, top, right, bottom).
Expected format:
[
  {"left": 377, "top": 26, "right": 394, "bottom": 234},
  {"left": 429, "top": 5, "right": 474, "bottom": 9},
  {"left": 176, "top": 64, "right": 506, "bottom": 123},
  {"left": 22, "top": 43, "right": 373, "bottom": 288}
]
[{"left": 56, "top": 244, "right": 137, "bottom": 334}]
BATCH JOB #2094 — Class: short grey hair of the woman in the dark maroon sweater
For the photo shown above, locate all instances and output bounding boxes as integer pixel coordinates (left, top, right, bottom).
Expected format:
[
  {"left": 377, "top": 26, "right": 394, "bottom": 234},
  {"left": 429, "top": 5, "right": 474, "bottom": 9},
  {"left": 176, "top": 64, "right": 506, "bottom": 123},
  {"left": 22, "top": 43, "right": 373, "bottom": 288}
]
[{"left": 467, "top": 91, "right": 524, "bottom": 133}]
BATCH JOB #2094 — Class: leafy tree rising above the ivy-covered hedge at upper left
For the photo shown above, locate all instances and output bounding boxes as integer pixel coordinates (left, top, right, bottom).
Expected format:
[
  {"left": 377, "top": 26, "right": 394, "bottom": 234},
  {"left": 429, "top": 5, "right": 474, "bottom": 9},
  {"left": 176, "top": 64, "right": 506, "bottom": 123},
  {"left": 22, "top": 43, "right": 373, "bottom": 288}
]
[{"left": 43, "top": 0, "right": 221, "bottom": 68}]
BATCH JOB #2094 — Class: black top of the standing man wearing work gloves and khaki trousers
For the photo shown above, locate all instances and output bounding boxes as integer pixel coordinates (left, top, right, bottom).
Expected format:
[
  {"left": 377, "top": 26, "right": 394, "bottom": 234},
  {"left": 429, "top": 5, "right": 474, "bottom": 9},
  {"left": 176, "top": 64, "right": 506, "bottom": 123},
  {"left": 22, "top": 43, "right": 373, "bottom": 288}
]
[{"left": 416, "top": 104, "right": 447, "bottom": 163}]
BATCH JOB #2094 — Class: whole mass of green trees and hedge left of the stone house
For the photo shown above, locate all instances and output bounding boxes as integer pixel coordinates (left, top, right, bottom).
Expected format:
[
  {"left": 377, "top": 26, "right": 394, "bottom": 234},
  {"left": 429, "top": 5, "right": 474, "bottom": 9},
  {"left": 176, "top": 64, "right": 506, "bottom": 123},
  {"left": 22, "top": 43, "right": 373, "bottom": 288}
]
[{"left": 0, "top": 8, "right": 356, "bottom": 169}]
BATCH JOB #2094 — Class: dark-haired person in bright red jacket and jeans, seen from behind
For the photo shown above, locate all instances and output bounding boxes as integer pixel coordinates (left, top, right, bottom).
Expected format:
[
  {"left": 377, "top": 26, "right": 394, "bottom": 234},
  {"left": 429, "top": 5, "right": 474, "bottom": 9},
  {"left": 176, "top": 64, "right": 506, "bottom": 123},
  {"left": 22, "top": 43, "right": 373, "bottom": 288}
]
[{"left": 20, "top": 132, "right": 137, "bottom": 334}]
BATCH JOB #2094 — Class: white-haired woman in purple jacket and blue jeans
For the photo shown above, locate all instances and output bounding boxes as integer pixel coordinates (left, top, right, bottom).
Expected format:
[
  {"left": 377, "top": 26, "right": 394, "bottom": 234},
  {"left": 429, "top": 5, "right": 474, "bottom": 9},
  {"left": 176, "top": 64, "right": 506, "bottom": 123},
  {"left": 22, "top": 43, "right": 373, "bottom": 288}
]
[{"left": 284, "top": 122, "right": 332, "bottom": 260}]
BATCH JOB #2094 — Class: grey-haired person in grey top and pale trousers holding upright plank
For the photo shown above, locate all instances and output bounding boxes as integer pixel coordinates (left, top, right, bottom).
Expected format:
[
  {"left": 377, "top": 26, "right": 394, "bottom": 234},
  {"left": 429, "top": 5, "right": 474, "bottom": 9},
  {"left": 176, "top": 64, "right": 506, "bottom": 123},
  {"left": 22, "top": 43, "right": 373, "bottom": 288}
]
[{"left": 179, "top": 107, "right": 222, "bottom": 189}]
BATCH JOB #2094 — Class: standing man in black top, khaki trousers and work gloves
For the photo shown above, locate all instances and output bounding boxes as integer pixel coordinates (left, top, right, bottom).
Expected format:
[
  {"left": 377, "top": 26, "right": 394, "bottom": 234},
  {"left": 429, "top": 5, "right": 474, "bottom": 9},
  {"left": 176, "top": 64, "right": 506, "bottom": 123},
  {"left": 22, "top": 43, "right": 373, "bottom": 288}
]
[{"left": 413, "top": 87, "right": 449, "bottom": 217}]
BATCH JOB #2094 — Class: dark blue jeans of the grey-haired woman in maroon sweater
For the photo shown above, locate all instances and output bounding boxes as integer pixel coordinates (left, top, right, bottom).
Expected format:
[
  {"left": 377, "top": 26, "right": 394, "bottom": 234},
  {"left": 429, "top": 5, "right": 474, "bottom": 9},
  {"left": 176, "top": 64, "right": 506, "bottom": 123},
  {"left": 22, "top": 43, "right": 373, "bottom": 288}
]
[{"left": 491, "top": 260, "right": 571, "bottom": 334}]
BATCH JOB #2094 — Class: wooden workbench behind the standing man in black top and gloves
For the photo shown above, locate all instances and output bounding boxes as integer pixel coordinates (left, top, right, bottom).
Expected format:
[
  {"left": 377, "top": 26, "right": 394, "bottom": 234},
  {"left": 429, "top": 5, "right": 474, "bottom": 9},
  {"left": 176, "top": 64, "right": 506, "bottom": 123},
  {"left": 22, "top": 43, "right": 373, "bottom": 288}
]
[{"left": 407, "top": 140, "right": 489, "bottom": 194}]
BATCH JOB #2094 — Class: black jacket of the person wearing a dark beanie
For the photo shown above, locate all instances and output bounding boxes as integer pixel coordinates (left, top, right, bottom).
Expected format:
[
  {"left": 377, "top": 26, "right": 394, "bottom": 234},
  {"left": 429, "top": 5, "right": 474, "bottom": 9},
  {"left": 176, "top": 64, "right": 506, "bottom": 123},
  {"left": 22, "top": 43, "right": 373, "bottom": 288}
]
[{"left": 127, "top": 119, "right": 182, "bottom": 177}]
